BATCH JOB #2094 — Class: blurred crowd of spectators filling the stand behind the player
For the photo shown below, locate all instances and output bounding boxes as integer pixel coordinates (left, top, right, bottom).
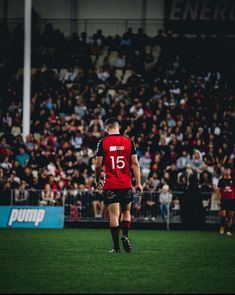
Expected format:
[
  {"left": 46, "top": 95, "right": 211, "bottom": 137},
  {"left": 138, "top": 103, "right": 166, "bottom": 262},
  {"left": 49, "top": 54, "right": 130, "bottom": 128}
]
[{"left": 0, "top": 21, "right": 235, "bottom": 224}]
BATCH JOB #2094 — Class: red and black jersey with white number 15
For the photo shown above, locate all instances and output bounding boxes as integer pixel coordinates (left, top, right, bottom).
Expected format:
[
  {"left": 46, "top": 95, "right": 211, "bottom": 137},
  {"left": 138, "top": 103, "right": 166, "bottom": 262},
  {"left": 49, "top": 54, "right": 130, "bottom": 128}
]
[{"left": 96, "top": 134, "right": 137, "bottom": 189}]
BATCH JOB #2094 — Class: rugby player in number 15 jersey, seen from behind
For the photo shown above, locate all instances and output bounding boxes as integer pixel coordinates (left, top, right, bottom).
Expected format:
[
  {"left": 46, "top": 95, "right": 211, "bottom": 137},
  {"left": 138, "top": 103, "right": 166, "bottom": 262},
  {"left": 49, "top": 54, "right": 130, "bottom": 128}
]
[{"left": 95, "top": 118, "right": 143, "bottom": 253}]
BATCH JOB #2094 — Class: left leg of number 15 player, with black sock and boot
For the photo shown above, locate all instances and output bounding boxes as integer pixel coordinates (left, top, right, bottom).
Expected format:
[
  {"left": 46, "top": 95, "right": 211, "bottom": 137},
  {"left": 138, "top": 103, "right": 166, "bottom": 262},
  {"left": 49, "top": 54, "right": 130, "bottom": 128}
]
[{"left": 108, "top": 203, "right": 120, "bottom": 253}]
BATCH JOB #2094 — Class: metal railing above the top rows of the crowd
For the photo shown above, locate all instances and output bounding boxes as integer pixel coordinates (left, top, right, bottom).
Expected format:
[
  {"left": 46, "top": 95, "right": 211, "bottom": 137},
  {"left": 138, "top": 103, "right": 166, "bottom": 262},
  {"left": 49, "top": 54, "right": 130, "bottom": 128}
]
[{"left": 0, "top": 19, "right": 164, "bottom": 37}]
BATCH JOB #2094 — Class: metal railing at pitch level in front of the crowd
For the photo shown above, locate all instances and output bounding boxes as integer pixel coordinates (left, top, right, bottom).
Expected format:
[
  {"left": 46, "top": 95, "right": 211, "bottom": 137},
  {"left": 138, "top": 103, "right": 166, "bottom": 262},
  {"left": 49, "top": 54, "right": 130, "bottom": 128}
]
[{"left": 0, "top": 189, "right": 220, "bottom": 229}]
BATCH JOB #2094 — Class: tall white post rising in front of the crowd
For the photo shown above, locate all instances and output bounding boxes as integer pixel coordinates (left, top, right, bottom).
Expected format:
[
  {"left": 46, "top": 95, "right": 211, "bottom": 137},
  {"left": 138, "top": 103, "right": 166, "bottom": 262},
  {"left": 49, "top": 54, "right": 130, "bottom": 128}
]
[{"left": 23, "top": 0, "right": 32, "bottom": 141}]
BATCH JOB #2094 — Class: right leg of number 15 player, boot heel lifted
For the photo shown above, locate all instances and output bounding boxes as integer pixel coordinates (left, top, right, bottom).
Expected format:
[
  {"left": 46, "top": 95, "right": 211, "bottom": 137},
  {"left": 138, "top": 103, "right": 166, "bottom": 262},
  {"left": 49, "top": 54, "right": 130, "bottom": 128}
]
[{"left": 121, "top": 203, "right": 131, "bottom": 252}]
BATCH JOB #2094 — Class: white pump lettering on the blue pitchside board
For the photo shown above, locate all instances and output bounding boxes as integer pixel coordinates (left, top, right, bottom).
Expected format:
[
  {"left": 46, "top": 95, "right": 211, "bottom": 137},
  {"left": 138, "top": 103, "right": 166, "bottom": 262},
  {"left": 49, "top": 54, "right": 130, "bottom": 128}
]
[{"left": 8, "top": 209, "right": 46, "bottom": 226}]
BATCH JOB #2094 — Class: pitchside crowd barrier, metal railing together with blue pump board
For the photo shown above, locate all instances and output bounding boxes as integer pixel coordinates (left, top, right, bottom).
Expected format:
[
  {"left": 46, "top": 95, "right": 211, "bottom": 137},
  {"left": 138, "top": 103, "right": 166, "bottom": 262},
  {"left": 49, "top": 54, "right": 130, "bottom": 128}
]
[{"left": 0, "top": 189, "right": 220, "bottom": 229}]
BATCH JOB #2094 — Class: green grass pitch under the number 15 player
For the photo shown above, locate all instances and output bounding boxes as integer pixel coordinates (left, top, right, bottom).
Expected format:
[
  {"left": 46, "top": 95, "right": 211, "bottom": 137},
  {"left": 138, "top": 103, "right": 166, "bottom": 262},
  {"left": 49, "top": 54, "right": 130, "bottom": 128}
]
[{"left": 0, "top": 229, "right": 235, "bottom": 293}]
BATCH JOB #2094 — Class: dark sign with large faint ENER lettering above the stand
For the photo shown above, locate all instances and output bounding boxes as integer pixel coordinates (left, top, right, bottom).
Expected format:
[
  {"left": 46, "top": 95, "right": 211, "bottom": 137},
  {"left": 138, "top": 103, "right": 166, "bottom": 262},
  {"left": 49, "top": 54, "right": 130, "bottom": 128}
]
[{"left": 165, "top": 0, "right": 235, "bottom": 34}]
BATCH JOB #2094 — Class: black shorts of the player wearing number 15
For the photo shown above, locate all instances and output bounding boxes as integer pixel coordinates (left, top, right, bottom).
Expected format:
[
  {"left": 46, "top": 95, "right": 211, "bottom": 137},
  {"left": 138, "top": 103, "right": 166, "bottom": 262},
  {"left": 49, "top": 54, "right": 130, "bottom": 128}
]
[{"left": 104, "top": 188, "right": 134, "bottom": 207}]
